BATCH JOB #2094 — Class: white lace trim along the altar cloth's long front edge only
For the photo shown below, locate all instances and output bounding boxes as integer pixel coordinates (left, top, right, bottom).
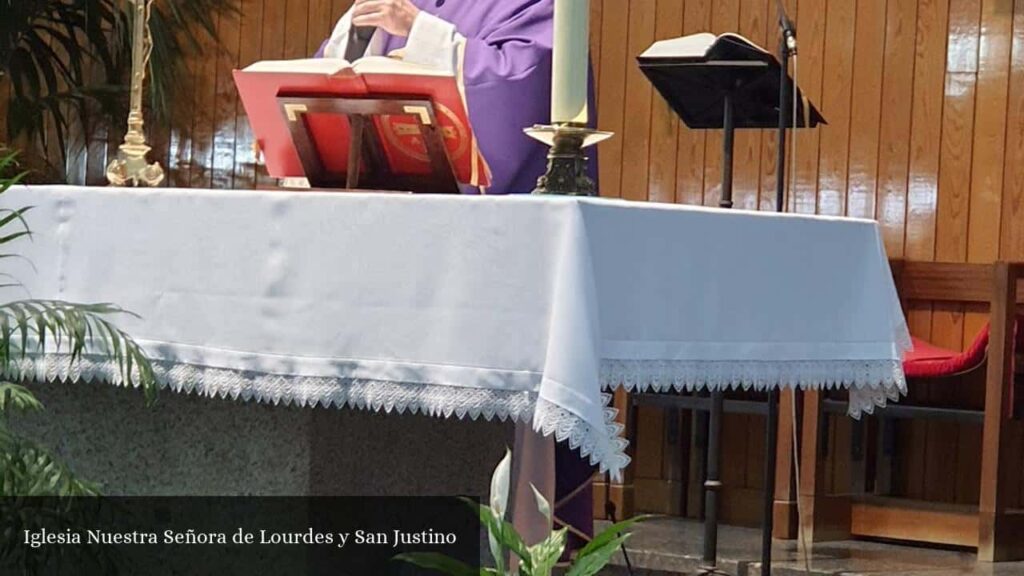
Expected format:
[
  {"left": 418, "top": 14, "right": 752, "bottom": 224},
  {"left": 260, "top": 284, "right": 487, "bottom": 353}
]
[{"left": 4, "top": 354, "right": 630, "bottom": 478}]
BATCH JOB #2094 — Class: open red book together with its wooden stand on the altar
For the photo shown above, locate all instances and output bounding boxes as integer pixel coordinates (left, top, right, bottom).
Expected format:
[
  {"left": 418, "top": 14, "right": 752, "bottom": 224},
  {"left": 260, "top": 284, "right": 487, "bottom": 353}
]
[{"left": 234, "top": 57, "right": 490, "bottom": 194}]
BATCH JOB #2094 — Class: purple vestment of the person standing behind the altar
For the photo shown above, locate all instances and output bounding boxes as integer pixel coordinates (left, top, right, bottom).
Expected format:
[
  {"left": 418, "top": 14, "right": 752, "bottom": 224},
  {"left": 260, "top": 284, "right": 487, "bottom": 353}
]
[{"left": 315, "top": 0, "right": 597, "bottom": 194}]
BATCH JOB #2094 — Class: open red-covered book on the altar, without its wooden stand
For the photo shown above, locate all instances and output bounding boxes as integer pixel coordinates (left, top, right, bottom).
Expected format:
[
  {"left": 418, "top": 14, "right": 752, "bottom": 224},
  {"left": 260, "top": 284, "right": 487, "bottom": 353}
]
[{"left": 234, "top": 56, "right": 490, "bottom": 187}]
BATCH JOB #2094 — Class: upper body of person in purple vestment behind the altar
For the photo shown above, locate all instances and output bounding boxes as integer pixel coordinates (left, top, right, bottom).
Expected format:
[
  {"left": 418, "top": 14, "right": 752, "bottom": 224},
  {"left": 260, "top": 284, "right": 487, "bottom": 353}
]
[{"left": 318, "top": 0, "right": 596, "bottom": 194}]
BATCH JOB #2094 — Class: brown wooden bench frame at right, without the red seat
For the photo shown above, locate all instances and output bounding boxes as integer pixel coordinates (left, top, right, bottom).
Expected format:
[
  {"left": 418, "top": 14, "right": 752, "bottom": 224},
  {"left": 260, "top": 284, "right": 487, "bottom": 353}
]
[{"left": 798, "top": 261, "right": 1024, "bottom": 562}]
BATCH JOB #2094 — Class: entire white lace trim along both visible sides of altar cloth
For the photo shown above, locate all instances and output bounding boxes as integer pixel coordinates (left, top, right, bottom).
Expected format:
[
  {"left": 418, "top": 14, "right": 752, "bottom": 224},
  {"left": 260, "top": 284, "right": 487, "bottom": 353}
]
[{"left": 5, "top": 354, "right": 906, "bottom": 478}]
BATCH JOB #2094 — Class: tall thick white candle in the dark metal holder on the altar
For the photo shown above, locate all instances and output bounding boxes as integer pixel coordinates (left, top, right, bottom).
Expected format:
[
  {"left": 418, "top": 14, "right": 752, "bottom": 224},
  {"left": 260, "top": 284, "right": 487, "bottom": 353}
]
[{"left": 551, "top": 0, "right": 590, "bottom": 124}]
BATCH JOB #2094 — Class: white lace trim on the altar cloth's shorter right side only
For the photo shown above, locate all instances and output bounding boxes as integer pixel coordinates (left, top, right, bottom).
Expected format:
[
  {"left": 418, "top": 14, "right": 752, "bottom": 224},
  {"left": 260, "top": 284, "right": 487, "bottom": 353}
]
[{"left": 601, "top": 360, "right": 906, "bottom": 419}]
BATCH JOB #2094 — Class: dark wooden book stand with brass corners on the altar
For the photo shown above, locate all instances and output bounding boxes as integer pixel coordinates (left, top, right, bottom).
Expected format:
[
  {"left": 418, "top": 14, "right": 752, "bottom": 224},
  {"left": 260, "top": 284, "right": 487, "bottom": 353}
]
[{"left": 278, "top": 95, "right": 459, "bottom": 194}]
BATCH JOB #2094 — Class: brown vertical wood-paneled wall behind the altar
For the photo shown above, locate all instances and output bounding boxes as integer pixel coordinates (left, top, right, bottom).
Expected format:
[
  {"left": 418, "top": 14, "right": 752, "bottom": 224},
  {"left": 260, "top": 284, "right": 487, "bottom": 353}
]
[{"left": 0, "top": 0, "right": 1024, "bottom": 520}]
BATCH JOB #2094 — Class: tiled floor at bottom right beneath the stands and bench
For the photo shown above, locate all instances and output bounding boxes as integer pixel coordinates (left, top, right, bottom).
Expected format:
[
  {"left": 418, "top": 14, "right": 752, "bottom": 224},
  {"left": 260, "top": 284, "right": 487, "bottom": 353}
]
[{"left": 606, "top": 519, "right": 1024, "bottom": 576}]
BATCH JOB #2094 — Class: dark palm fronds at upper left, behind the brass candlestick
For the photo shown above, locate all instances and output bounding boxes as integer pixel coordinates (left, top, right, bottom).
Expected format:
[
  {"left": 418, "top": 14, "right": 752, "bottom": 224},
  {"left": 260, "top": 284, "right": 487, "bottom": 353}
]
[{"left": 0, "top": 0, "right": 240, "bottom": 176}]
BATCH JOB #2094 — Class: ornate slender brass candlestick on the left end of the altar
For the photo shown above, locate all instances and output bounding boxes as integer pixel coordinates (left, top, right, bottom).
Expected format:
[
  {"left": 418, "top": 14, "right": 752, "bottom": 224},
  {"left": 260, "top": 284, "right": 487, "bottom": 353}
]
[{"left": 106, "top": 0, "right": 164, "bottom": 187}]
